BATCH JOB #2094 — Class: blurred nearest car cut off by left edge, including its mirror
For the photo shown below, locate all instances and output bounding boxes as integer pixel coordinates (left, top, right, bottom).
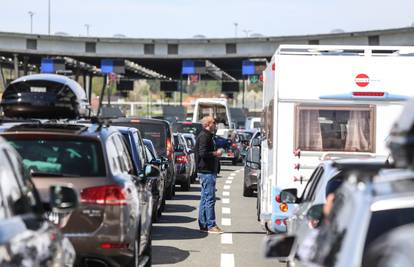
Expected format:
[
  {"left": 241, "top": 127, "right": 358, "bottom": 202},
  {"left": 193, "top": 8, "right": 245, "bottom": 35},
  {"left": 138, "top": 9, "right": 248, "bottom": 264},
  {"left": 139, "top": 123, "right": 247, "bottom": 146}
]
[{"left": 0, "top": 138, "right": 78, "bottom": 266}]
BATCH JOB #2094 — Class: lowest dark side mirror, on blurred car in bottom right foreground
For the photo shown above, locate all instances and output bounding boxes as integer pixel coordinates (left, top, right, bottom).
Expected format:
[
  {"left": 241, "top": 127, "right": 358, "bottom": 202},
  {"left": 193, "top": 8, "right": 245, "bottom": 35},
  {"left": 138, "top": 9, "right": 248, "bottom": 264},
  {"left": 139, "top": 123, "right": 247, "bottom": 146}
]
[{"left": 264, "top": 235, "right": 296, "bottom": 260}]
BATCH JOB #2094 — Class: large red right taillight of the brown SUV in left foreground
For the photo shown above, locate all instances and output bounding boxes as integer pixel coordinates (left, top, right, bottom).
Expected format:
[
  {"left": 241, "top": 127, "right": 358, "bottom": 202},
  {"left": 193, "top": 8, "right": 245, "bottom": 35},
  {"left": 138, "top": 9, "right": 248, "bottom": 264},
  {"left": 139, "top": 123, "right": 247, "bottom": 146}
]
[{"left": 80, "top": 185, "right": 127, "bottom": 206}]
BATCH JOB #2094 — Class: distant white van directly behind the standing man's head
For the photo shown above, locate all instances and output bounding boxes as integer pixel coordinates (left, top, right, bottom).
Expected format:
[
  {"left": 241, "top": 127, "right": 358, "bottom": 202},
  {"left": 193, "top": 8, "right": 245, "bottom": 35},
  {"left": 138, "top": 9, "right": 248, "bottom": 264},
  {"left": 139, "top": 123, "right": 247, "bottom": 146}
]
[{"left": 193, "top": 98, "right": 233, "bottom": 134}]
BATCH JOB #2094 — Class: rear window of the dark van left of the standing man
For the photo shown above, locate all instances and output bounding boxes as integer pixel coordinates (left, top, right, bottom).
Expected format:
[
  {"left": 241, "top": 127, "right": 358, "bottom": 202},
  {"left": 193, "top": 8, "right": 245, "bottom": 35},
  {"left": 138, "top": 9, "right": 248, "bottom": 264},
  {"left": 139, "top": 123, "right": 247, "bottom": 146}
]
[{"left": 133, "top": 122, "right": 167, "bottom": 157}]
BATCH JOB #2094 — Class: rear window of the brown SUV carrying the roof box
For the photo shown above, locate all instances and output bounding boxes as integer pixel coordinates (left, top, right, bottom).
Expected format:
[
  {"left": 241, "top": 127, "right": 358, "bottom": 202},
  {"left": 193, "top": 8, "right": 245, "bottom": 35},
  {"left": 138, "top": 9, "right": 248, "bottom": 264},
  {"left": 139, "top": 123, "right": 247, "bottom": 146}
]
[{"left": 6, "top": 136, "right": 106, "bottom": 177}]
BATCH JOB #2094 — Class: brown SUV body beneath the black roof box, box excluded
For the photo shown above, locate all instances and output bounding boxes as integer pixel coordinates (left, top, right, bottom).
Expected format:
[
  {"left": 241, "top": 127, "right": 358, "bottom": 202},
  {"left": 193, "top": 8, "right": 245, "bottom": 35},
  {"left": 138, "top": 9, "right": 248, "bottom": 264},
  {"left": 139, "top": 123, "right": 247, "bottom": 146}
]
[{"left": 0, "top": 122, "right": 153, "bottom": 266}]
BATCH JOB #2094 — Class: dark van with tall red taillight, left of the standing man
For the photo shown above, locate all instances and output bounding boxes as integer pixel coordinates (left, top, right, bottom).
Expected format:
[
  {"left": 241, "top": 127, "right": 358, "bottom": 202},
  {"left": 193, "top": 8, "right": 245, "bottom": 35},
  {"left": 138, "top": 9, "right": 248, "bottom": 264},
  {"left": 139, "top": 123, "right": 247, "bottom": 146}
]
[{"left": 111, "top": 117, "right": 176, "bottom": 199}]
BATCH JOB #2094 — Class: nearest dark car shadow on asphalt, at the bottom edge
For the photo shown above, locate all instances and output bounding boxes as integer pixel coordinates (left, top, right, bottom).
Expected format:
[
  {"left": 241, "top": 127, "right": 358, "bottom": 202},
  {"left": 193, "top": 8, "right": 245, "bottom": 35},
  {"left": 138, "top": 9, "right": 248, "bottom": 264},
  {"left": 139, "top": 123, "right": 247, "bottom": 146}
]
[{"left": 152, "top": 246, "right": 190, "bottom": 265}]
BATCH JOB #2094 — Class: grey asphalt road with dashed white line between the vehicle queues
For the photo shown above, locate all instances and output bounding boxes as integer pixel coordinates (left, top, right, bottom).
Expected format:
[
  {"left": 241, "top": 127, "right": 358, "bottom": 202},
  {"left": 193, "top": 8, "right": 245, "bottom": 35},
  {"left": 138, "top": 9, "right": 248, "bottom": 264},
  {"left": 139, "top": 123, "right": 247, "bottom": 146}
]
[{"left": 152, "top": 165, "right": 282, "bottom": 267}]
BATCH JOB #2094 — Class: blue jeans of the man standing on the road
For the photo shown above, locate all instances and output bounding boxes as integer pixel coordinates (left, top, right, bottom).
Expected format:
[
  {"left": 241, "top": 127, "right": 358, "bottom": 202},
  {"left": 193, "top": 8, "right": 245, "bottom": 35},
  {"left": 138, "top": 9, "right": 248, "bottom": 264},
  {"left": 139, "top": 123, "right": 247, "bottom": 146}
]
[{"left": 197, "top": 173, "right": 216, "bottom": 229}]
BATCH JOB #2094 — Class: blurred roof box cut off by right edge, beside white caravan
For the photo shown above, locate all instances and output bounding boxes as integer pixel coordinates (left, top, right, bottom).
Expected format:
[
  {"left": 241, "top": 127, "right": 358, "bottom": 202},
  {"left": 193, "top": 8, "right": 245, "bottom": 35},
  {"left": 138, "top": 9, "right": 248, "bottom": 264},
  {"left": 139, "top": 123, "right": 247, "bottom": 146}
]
[{"left": 387, "top": 98, "right": 414, "bottom": 168}]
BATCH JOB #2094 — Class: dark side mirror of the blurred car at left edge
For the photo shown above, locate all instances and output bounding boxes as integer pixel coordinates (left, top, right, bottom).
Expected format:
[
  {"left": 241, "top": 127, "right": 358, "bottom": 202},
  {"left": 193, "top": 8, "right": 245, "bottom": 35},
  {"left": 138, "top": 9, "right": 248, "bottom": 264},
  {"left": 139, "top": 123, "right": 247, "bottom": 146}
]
[{"left": 49, "top": 185, "right": 79, "bottom": 213}]
